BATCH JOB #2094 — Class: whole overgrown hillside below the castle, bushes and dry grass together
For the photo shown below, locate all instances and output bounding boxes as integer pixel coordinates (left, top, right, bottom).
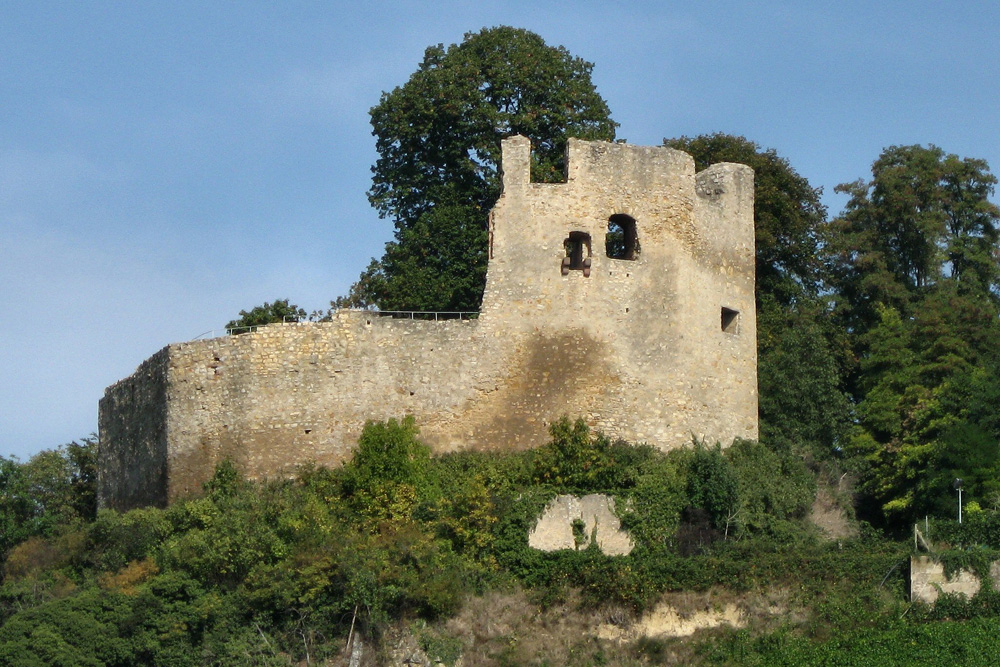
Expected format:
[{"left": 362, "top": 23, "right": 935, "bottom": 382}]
[{"left": 0, "top": 419, "right": 1000, "bottom": 666}]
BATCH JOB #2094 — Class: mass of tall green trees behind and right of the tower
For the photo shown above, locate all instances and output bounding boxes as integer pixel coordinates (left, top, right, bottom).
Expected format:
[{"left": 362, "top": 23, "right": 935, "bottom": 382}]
[{"left": 665, "top": 135, "right": 1000, "bottom": 529}]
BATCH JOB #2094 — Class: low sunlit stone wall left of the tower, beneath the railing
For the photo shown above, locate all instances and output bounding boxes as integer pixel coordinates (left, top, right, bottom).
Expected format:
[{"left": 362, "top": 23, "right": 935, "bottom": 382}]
[{"left": 159, "top": 311, "right": 497, "bottom": 500}]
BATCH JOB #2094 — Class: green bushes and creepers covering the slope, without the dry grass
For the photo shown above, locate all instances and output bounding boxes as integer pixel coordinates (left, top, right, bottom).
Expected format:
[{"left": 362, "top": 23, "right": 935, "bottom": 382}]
[{"left": 0, "top": 419, "right": 1000, "bottom": 665}]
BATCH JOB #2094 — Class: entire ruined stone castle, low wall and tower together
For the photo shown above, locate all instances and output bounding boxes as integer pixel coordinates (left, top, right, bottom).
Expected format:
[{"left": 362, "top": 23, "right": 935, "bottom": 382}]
[{"left": 99, "top": 137, "right": 757, "bottom": 509}]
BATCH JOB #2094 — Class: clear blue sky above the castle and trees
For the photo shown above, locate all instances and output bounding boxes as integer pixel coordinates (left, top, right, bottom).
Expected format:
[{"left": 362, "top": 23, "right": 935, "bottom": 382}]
[{"left": 0, "top": 0, "right": 1000, "bottom": 459}]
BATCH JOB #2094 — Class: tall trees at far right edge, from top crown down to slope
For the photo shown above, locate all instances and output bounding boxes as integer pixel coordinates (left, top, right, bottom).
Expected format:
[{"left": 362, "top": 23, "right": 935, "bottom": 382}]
[{"left": 825, "top": 146, "right": 1000, "bottom": 521}]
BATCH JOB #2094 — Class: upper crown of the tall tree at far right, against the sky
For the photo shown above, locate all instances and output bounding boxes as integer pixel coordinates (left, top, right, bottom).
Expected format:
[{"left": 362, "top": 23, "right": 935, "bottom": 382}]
[{"left": 826, "top": 146, "right": 1000, "bottom": 333}]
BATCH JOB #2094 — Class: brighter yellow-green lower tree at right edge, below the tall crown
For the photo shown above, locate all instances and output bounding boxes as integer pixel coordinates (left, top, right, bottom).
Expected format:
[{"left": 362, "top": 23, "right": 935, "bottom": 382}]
[{"left": 849, "top": 283, "right": 1000, "bottom": 525}]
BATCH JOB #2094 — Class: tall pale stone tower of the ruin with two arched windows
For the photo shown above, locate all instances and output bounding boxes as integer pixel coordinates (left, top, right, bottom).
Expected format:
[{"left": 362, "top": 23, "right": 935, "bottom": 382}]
[{"left": 482, "top": 138, "right": 757, "bottom": 448}]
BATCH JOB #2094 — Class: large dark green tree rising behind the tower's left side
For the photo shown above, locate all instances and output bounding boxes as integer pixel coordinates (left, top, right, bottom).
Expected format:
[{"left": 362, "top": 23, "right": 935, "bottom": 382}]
[{"left": 350, "top": 27, "right": 616, "bottom": 310}]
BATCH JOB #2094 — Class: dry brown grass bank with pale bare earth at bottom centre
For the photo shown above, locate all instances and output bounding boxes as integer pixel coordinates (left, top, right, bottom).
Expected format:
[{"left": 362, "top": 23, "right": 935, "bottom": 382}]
[{"left": 368, "top": 589, "right": 806, "bottom": 667}]
